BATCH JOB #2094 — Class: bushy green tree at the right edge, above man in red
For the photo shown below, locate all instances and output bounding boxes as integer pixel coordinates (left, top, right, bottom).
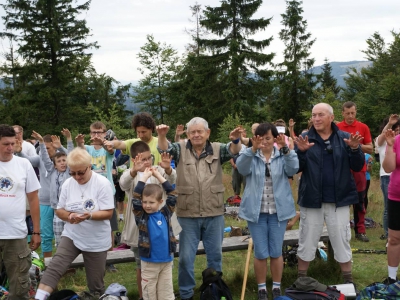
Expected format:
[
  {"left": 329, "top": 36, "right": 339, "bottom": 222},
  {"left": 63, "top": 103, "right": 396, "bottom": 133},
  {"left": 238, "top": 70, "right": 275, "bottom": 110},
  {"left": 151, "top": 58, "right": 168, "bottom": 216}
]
[{"left": 342, "top": 31, "right": 400, "bottom": 135}]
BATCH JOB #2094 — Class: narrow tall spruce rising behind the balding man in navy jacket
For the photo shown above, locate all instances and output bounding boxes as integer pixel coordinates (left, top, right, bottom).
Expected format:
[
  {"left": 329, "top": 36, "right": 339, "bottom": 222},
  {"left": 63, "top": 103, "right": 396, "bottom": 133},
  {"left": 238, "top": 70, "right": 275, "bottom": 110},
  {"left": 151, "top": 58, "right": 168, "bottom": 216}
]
[{"left": 271, "top": 0, "right": 316, "bottom": 128}]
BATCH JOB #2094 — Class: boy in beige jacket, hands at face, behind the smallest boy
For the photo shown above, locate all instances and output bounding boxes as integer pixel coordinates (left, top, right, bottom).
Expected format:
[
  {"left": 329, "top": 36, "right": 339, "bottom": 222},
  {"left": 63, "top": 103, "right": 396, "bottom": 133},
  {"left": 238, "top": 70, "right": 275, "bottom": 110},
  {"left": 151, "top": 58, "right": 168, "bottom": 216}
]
[{"left": 119, "top": 141, "right": 181, "bottom": 298}]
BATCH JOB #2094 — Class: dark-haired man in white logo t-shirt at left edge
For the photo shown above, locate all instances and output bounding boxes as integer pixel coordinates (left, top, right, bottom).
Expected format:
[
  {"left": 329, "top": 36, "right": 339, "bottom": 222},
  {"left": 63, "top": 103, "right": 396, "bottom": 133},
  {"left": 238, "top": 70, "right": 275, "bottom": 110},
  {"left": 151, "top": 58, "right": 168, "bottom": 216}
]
[{"left": 0, "top": 124, "right": 41, "bottom": 300}]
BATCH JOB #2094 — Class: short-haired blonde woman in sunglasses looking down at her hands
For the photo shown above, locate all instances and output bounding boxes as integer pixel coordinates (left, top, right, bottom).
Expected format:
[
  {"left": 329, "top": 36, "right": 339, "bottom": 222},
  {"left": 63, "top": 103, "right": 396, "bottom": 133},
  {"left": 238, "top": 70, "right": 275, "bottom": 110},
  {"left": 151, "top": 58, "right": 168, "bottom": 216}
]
[{"left": 35, "top": 148, "right": 114, "bottom": 300}]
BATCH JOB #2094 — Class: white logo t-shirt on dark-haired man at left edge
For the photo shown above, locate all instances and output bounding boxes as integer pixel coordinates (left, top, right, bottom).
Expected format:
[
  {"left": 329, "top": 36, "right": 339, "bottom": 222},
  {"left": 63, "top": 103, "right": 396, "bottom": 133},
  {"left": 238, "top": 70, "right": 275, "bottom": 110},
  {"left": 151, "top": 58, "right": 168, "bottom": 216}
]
[{"left": 0, "top": 156, "right": 40, "bottom": 239}]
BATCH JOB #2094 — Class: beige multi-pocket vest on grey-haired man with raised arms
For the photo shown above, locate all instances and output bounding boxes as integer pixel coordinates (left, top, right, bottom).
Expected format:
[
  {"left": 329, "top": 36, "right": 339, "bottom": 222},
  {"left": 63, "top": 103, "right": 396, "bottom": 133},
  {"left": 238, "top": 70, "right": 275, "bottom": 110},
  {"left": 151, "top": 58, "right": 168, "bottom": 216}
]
[{"left": 176, "top": 142, "right": 225, "bottom": 218}]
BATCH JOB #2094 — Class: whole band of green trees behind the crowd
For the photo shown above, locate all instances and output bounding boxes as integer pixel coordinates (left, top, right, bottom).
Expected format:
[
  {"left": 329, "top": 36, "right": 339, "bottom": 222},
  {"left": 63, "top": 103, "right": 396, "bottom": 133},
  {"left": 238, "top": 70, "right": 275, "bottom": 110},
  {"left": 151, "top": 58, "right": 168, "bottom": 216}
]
[{"left": 0, "top": 0, "right": 400, "bottom": 141}]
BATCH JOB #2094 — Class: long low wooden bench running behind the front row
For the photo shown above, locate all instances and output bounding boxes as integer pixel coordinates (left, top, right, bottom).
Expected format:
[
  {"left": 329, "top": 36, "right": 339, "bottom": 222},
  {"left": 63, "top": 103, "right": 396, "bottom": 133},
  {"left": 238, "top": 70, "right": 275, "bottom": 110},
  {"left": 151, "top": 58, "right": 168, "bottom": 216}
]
[{"left": 45, "top": 227, "right": 329, "bottom": 268}]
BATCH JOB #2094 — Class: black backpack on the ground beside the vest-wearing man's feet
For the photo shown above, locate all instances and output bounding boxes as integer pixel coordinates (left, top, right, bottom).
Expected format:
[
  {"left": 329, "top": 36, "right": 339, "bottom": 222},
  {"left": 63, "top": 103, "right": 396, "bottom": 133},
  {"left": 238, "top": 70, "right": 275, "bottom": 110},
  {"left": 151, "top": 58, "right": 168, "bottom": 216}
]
[{"left": 200, "top": 268, "right": 233, "bottom": 300}]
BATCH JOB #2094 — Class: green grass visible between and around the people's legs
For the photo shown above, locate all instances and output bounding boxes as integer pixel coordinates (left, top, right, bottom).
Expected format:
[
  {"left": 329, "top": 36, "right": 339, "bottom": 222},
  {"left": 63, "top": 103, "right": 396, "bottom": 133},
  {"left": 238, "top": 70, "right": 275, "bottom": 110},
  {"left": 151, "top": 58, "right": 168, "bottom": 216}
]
[{"left": 54, "top": 170, "right": 387, "bottom": 300}]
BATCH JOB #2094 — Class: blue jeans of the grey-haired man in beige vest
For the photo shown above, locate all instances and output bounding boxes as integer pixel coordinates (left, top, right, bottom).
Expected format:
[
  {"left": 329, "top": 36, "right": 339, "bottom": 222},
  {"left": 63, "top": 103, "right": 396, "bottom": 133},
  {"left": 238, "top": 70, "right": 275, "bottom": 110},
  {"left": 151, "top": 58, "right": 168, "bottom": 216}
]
[{"left": 178, "top": 216, "right": 225, "bottom": 299}]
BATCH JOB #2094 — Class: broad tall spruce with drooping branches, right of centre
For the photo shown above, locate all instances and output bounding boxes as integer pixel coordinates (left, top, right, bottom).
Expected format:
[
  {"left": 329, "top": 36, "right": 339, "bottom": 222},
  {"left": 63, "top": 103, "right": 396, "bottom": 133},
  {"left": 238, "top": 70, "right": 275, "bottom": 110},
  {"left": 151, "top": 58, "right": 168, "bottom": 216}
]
[{"left": 199, "top": 0, "right": 274, "bottom": 118}]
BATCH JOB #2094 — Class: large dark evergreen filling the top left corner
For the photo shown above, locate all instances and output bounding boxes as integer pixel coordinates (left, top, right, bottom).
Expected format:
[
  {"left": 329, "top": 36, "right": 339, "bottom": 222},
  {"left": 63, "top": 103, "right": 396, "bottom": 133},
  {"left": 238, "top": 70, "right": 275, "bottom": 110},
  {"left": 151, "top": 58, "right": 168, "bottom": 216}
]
[{"left": 2, "top": 0, "right": 97, "bottom": 128}]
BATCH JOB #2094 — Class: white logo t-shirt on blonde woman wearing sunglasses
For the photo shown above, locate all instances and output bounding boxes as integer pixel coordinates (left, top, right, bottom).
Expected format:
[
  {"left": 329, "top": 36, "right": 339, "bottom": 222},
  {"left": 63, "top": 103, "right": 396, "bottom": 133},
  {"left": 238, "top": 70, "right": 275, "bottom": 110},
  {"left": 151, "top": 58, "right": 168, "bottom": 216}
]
[{"left": 57, "top": 172, "right": 114, "bottom": 252}]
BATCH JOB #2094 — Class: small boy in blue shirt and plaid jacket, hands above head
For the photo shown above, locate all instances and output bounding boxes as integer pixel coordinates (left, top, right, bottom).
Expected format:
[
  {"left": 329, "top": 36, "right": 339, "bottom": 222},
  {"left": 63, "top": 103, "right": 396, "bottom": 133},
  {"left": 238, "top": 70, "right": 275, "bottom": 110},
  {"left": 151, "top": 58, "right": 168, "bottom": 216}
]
[{"left": 132, "top": 167, "right": 177, "bottom": 300}]
